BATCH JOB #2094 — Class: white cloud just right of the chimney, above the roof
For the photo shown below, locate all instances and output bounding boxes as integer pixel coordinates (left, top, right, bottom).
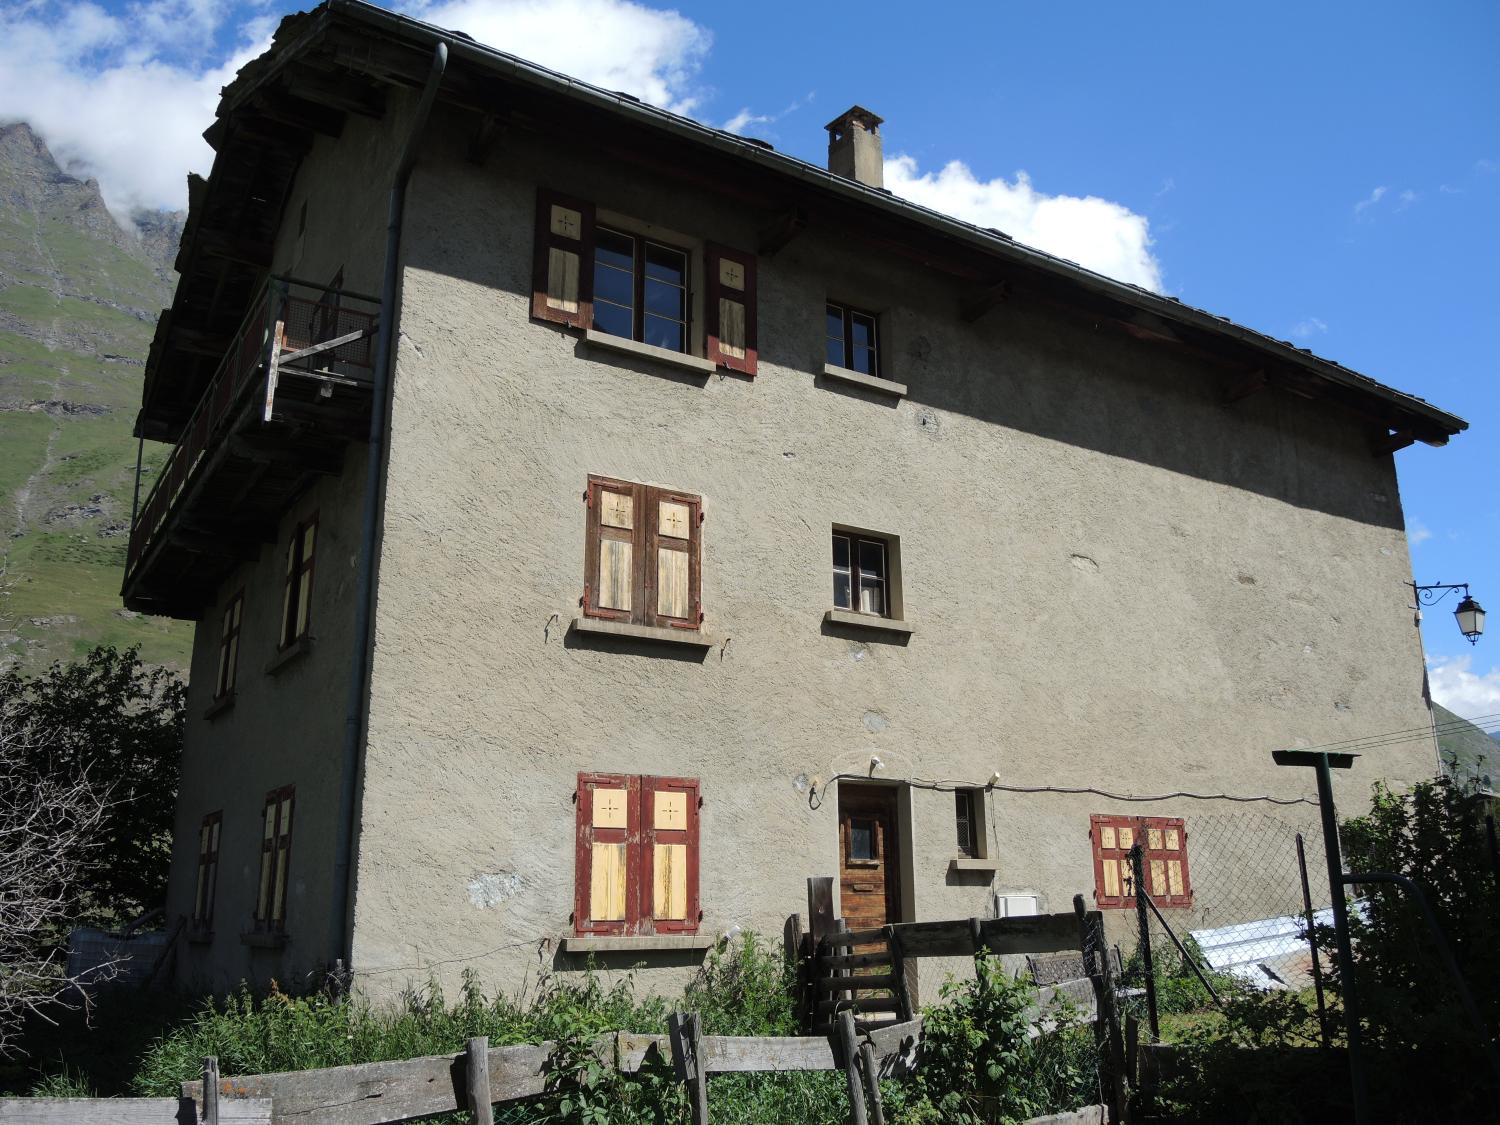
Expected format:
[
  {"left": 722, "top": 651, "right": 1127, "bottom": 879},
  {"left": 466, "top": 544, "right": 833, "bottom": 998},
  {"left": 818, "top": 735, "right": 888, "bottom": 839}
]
[{"left": 885, "top": 156, "right": 1163, "bottom": 293}]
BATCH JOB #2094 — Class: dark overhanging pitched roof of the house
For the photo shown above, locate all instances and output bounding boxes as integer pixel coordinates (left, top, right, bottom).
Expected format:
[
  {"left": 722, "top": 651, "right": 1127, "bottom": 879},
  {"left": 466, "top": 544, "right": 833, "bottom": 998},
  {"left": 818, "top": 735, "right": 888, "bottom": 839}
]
[{"left": 143, "top": 0, "right": 1469, "bottom": 449}]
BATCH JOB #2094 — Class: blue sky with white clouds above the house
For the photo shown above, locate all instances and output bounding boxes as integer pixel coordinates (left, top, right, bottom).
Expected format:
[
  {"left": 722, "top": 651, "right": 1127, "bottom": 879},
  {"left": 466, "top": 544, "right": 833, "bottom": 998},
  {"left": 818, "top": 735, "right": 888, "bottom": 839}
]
[{"left": 0, "top": 0, "right": 1500, "bottom": 716}]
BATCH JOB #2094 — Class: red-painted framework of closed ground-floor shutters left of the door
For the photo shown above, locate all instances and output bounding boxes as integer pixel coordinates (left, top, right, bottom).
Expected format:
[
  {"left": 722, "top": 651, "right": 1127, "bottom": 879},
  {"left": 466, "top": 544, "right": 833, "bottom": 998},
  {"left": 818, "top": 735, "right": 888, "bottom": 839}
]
[{"left": 572, "top": 773, "right": 704, "bottom": 936}]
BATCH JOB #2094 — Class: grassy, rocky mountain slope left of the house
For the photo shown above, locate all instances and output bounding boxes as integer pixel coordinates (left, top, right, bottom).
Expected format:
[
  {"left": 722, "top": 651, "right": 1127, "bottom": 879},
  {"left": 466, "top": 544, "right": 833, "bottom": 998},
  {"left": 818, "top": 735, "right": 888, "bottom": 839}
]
[{"left": 0, "top": 125, "right": 192, "bottom": 668}]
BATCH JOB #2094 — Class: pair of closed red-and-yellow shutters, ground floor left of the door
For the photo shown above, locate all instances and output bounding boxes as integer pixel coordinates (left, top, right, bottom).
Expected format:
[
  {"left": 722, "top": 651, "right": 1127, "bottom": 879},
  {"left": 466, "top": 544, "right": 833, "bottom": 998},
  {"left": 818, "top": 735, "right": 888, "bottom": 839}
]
[{"left": 573, "top": 774, "right": 701, "bottom": 935}]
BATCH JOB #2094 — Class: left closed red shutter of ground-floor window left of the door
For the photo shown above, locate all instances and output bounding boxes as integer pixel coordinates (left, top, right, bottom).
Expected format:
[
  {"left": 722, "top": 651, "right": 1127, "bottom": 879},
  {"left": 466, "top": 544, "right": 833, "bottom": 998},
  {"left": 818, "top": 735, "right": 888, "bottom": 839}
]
[{"left": 573, "top": 774, "right": 641, "bottom": 933}]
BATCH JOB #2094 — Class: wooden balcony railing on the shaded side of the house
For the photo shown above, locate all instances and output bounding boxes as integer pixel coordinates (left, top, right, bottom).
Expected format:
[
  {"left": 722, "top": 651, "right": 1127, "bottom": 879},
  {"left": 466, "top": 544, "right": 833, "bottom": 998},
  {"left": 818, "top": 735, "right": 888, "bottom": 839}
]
[{"left": 126, "top": 278, "right": 380, "bottom": 588}]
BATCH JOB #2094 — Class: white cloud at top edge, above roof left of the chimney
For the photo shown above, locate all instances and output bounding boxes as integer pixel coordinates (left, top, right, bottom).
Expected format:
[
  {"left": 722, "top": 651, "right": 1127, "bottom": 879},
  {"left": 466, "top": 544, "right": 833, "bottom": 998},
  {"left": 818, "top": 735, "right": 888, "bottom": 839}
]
[{"left": 405, "top": 0, "right": 714, "bottom": 114}]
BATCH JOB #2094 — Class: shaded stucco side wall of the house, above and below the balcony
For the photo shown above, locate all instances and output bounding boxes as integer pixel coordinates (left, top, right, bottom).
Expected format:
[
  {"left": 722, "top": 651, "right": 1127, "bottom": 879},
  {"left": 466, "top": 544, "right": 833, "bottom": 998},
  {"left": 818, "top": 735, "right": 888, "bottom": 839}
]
[{"left": 168, "top": 105, "right": 399, "bottom": 989}]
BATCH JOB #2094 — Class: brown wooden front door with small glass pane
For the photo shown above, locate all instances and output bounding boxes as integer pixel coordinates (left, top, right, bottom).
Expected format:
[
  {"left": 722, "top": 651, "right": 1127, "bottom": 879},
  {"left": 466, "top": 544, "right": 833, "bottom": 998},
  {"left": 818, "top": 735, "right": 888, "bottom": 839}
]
[{"left": 839, "top": 783, "right": 902, "bottom": 930}]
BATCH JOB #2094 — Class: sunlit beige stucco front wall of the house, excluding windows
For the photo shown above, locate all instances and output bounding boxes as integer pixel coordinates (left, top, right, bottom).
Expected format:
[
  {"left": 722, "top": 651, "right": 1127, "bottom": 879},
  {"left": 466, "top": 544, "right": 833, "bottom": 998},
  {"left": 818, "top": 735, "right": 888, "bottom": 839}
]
[{"left": 345, "top": 122, "right": 1433, "bottom": 995}]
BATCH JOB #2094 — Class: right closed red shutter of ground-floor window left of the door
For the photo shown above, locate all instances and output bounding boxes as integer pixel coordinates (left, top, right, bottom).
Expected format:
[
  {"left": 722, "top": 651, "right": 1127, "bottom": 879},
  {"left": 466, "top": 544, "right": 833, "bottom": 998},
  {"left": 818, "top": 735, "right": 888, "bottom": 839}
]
[{"left": 639, "top": 777, "right": 699, "bottom": 933}]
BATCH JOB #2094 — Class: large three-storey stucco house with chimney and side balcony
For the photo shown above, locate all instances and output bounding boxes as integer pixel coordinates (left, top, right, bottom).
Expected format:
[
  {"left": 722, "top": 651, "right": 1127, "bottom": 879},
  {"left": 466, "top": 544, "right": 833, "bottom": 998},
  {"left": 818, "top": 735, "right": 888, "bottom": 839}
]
[{"left": 125, "top": 0, "right": 1466, "bottom": 995}]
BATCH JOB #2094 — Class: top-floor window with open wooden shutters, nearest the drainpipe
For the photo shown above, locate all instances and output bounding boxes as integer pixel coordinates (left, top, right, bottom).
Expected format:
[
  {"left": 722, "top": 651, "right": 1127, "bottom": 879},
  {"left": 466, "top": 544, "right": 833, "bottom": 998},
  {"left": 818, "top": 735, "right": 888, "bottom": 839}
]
[{"left": 531, "top": 189, "right": 758, "bottom": 375}]
